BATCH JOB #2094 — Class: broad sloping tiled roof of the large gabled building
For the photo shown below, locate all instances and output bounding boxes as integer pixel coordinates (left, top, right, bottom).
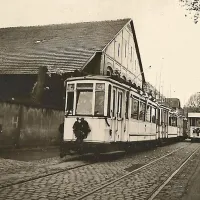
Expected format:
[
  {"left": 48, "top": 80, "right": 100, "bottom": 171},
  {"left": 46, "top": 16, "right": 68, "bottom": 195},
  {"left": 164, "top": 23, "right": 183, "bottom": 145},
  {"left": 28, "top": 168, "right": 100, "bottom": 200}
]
[{"left": 0, "top": 19, "right": 130, "bottom": 74}]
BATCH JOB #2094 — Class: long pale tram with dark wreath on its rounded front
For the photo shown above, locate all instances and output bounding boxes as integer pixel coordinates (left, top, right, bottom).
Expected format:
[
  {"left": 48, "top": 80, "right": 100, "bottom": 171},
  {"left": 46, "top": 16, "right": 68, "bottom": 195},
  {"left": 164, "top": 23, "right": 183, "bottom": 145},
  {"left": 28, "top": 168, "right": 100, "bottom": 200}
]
[{"left": 61, "top": 76, "right": 186, "bottom": 157}]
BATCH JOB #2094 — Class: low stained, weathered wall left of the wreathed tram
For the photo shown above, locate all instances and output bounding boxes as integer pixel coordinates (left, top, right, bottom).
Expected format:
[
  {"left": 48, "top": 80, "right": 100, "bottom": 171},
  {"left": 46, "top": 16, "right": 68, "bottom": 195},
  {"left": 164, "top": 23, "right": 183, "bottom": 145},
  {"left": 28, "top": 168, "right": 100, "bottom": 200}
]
[{"left": 0, "top": 102, "right": 64, "bottom": 146}]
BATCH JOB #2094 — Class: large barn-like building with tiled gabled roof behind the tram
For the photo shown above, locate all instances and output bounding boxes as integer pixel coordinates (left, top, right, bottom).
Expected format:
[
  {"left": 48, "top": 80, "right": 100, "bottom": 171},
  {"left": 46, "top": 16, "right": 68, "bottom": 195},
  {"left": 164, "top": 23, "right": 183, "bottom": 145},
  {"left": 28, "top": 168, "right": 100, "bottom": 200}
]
[{"left": 0, "top": 19, "right": 145, "bottom": 106}]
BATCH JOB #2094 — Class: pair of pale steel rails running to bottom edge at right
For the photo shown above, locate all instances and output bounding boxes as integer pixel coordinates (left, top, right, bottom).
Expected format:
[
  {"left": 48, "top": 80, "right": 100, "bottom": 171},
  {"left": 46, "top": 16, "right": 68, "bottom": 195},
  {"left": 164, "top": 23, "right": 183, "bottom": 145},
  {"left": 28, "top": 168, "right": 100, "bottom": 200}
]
[{"left": 76, "top": 145, "right": 200, "bottom": 200}]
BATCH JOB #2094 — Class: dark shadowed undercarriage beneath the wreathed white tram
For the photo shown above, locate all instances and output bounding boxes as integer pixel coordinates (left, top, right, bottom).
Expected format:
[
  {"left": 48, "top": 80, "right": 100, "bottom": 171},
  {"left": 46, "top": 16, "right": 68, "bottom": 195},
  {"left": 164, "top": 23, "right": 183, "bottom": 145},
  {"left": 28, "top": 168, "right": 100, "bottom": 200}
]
[{"left": 60, "top": 137, "right": 183, "bottom": 158}]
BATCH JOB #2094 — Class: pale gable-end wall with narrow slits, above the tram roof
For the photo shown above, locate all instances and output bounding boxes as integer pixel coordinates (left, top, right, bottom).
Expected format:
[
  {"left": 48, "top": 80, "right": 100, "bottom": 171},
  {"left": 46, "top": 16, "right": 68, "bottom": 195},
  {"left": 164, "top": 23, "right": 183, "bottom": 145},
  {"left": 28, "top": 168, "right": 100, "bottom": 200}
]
[{"left": 103, "top": 24, "right": 142, "bottom": 87}]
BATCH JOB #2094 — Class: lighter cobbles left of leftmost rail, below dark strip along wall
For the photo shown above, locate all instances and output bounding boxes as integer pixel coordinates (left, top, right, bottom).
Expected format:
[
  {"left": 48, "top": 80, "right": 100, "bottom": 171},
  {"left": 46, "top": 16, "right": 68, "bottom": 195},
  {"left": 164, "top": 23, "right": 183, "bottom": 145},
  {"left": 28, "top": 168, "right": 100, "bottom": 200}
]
[{"left": 0, "top": 152, "right": 87, "bottom": 188}]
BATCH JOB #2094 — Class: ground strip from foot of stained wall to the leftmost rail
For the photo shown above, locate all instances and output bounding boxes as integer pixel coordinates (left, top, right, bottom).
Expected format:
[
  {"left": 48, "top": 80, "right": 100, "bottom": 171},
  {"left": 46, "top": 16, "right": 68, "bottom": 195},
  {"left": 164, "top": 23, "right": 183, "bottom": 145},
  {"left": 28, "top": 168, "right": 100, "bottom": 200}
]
[{"left": 0, "top": 147, "right": 91, "bottom": 188}]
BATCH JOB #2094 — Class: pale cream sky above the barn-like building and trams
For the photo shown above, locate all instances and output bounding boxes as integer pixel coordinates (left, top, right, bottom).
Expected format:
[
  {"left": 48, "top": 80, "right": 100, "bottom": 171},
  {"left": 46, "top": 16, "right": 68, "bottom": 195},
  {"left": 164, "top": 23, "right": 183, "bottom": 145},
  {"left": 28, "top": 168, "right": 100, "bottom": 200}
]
[{"left": 0, "top": 0, "right": 200, "bottom": 105}]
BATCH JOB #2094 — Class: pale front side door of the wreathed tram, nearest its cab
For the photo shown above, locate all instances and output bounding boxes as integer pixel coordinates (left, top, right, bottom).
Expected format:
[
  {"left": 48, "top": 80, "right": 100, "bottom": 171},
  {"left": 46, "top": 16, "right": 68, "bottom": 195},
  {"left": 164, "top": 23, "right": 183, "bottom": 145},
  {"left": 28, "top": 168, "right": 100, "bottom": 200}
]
[{"left": 113, "top": 88, "right": 124, "bottom": 142}]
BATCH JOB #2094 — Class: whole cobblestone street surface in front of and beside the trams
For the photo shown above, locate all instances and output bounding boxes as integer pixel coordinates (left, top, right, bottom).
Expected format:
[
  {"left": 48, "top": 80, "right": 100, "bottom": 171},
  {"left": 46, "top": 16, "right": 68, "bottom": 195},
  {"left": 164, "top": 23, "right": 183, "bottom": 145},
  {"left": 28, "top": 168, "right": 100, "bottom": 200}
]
[{"left": 0, "top": 142, "right": 199, "bottom": 200}]
